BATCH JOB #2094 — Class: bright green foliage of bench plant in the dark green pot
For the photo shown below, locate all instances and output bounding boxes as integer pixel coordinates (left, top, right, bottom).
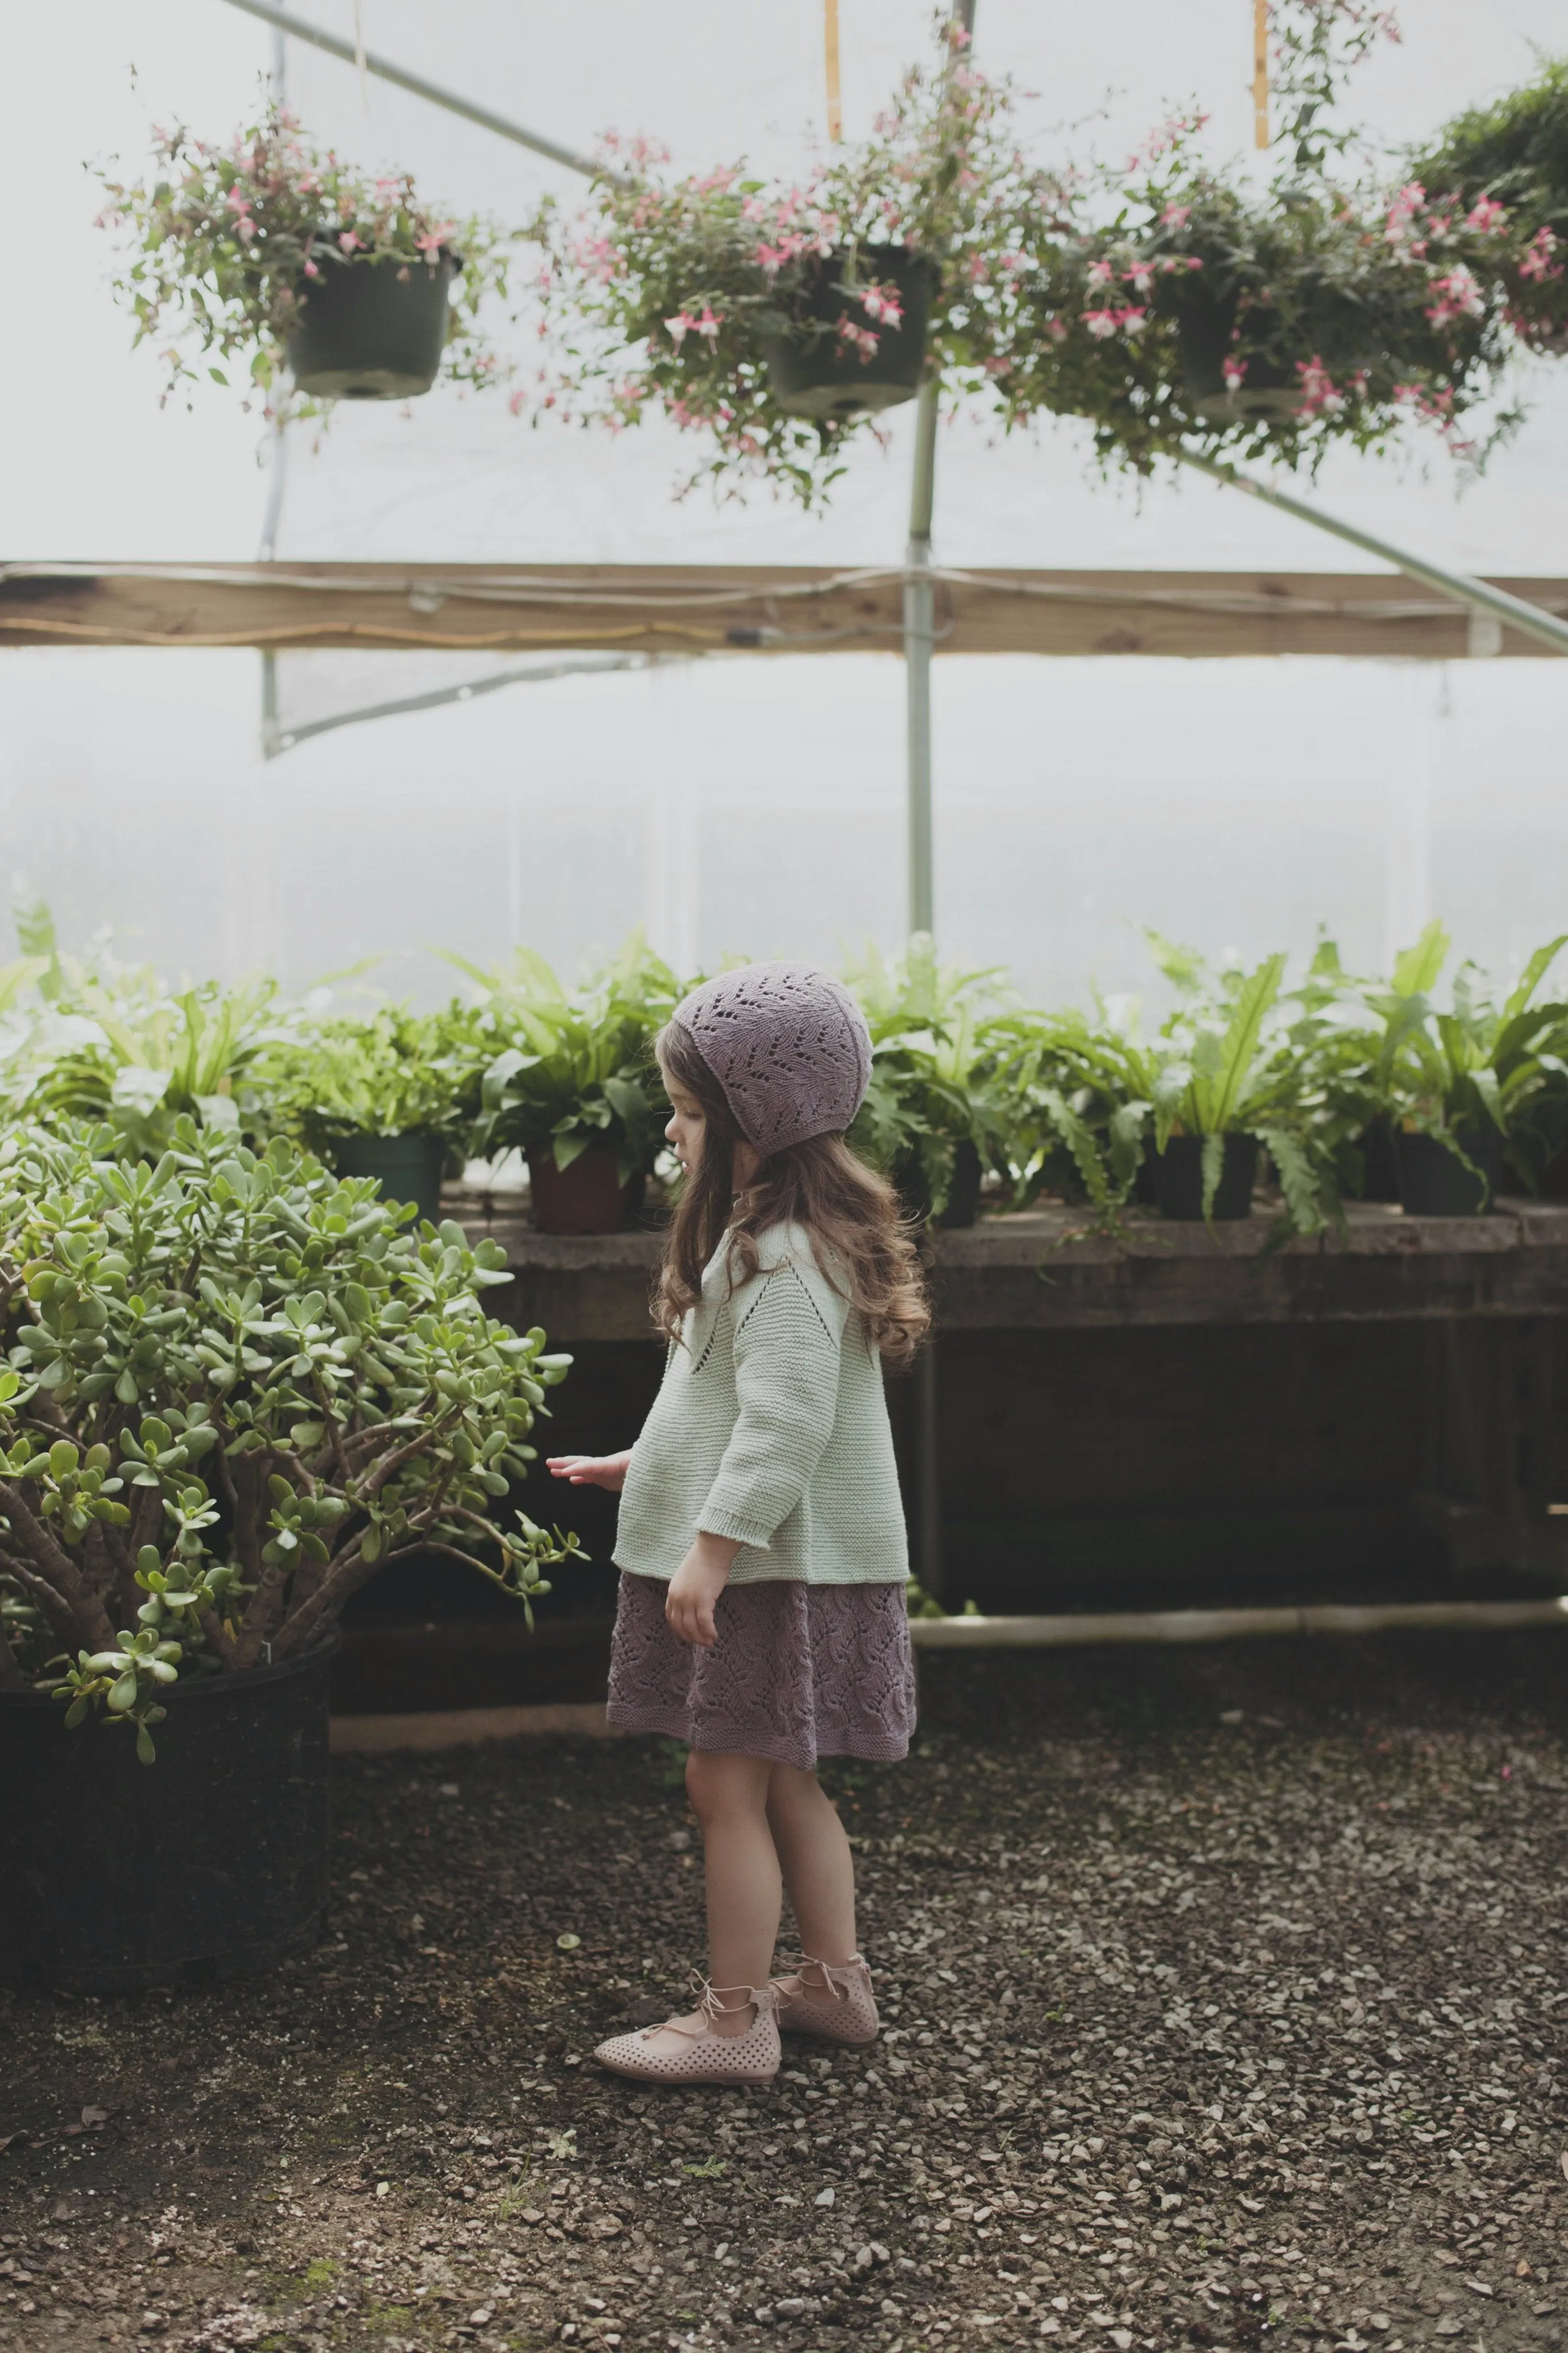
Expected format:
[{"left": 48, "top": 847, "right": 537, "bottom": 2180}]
[{"left": 258, "top": 1002, "right": 489, "bottom": 1155}]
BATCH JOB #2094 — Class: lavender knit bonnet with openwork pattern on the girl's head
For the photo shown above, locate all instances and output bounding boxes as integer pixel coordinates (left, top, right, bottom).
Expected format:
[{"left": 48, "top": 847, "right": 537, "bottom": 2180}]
[{"left": 675, "top": 962, "right": 872, "bottom": 1158}]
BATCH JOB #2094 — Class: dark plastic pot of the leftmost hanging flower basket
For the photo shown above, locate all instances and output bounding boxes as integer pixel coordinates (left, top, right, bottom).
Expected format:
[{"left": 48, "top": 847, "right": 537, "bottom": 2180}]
[{"left": 289, "top": 254, "right": 463, "bottom": 400}]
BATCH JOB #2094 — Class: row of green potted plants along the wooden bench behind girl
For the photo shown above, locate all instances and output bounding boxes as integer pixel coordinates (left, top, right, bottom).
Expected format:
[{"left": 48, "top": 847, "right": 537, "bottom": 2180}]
[{"left": 0, "top": 911, "right": 1568, "bottom": 1233}]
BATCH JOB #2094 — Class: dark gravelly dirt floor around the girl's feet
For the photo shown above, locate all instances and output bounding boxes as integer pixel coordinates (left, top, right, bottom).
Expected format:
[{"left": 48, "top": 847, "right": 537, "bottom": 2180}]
[{"left": 0, "top": 1635, "right": 1568, "bottom": 2353}]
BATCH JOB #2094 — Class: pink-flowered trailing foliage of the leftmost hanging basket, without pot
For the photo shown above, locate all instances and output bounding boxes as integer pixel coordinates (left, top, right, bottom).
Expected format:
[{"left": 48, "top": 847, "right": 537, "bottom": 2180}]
[{"left": 99, "top": 103, "right": 510, "bottom": 414}]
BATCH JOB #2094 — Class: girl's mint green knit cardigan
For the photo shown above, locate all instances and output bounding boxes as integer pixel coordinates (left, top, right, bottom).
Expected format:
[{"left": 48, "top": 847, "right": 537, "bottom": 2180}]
[{"left": 613, "top": 1226, "right": 910, "bottom": 1586}]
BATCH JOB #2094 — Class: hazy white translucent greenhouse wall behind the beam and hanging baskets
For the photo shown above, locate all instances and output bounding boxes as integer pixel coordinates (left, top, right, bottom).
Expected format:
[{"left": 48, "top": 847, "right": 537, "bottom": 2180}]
[{"left": 0, "top": 0, "right": 1568, "bottom": 1002}]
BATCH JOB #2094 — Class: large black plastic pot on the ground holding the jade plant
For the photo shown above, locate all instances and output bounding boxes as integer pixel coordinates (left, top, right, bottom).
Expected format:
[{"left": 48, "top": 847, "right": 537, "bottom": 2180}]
[{"left": 0, "top": 1640, "right": 336, "bottom": 1993}]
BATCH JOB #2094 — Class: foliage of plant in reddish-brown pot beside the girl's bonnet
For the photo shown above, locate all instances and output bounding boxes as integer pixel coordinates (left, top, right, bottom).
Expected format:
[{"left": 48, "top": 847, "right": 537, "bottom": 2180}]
[{"left": 449, "top": 932, "right": 682, "bottom": 1183}]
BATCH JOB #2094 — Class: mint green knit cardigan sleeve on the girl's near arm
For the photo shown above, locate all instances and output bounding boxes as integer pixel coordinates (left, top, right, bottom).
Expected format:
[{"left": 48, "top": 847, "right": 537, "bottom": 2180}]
[{"left": 696, "top": 1259, "right": 849, "bottom": 1550}]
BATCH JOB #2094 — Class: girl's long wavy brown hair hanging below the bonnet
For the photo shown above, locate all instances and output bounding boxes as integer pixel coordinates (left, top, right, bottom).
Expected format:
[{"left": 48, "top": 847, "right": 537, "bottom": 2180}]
[{"left": 654, "top": 1021, "right": 931, "bottom": 1372}]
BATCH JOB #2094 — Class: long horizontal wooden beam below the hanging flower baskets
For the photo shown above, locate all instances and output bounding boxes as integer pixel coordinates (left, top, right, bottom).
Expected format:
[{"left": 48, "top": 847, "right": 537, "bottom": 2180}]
[{"left": 0, "top": 562, "right": 1568, "bottom": 661}]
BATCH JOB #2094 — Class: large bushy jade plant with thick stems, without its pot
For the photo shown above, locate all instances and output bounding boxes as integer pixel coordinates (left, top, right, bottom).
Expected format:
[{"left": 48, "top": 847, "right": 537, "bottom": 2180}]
[{"left": 0, "top": 1118, "right": 576, "bottom": 1762}]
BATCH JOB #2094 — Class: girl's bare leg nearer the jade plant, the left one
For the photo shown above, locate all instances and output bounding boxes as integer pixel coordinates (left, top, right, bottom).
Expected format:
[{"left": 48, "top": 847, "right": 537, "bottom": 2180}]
[{"left": 654, "top": 1748, "right": 783, "bottom": 2052}]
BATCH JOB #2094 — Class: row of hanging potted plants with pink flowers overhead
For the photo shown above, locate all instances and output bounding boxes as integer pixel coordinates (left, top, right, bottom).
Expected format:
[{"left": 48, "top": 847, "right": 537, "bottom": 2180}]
[{"left": 103, "top": 0, "right": 1568, "bottom": 492}]
